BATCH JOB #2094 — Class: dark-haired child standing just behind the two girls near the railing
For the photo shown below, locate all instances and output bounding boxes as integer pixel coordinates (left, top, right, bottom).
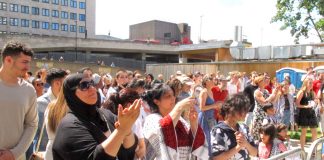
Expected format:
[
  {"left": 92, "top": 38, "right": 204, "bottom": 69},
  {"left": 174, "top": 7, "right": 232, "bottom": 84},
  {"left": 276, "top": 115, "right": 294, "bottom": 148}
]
[{"left": 262, "top": 103, "right": 279, "bottom": 125}]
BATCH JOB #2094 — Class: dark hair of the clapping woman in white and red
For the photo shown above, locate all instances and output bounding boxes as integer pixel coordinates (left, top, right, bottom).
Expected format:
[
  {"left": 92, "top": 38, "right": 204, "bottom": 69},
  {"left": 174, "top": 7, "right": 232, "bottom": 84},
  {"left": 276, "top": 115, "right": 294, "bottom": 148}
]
[{"left": 142, "top": 83, "right": 173, "bottom": 113}]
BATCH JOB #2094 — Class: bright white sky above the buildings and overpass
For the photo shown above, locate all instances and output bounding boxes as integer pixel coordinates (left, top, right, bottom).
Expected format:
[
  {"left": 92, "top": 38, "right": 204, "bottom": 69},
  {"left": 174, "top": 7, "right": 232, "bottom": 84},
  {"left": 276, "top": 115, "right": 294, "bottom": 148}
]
[{"left": 96, "top": 0, "right": 319, "bottom": 47}]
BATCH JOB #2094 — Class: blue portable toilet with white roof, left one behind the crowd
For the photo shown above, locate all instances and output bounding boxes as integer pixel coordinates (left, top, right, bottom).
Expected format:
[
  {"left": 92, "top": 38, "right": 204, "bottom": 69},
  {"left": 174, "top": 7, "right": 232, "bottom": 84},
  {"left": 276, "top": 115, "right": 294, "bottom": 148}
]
[{"left": 276, "top": 67, "right": 307, "bottom": 89}]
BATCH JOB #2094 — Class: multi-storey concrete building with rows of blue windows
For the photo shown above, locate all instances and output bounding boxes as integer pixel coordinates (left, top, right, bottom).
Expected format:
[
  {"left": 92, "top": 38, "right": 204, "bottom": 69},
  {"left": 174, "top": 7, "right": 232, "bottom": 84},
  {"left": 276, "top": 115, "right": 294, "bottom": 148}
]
[{"left": 0, "top": 0, "right": 96, "bottom": 38}]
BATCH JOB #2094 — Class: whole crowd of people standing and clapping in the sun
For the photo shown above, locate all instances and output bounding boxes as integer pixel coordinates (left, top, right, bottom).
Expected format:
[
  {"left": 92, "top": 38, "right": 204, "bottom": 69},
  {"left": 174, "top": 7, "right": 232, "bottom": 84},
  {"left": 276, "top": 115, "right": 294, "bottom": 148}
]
[{"left": 0, "top": 42, "right": 324, "bottom": 160}]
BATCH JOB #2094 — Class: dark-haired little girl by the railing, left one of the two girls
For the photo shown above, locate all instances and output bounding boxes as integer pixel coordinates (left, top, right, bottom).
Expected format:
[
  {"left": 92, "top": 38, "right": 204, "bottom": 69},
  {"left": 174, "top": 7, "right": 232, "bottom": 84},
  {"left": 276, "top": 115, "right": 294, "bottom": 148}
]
[{"left": 258, "top": 124, "right": 287, "bottom": 160}]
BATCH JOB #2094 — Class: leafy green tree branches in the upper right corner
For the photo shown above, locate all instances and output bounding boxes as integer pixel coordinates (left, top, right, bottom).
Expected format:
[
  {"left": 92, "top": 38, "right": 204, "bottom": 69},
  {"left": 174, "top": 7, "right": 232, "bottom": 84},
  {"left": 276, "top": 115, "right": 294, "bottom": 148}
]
[{"left": 271, "top": 0, "right": 324, "bottom": 43}]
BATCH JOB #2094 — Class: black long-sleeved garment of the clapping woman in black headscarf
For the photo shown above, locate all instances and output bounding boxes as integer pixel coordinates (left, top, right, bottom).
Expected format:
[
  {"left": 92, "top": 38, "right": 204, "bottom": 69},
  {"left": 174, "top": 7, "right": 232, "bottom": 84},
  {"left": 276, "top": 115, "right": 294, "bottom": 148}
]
[{"left": 53, "top": 109, "right": 138, "bottom": 160}]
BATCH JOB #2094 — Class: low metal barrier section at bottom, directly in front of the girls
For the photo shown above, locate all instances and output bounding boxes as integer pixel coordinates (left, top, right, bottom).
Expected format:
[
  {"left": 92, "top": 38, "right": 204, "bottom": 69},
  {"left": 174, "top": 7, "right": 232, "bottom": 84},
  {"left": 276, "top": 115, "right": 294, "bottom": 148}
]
[{"left": 268, "top": 147, "right": 306, "bottom": 160}]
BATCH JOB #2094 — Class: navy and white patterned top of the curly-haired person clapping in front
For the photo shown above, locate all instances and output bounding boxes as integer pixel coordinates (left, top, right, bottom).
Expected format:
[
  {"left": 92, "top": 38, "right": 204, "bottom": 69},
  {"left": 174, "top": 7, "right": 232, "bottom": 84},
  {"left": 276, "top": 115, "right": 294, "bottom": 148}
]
[{"left": 211, "top": 122, "right": 255, "bottom": 160}]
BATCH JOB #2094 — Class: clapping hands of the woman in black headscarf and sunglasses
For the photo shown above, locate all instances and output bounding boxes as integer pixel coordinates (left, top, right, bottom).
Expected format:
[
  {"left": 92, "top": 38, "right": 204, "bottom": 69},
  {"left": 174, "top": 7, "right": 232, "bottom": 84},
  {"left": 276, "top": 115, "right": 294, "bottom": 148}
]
[{"left": 115, "top": 99, "right": 142, "bottom": 136}]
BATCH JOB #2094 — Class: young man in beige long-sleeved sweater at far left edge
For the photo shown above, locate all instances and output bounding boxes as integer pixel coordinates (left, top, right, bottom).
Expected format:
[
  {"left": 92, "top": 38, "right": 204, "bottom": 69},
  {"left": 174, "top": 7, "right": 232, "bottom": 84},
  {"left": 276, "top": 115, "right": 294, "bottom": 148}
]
[{"left": 0, "top": 42, "right": 38, "bottom": 160}]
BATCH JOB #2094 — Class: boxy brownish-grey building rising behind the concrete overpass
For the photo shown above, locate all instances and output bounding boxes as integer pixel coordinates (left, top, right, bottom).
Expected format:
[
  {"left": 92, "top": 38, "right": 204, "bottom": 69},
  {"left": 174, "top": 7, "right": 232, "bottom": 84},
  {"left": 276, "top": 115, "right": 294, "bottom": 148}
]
[{"left": 129, "top": 20, "right": 192, "bottom": 44}]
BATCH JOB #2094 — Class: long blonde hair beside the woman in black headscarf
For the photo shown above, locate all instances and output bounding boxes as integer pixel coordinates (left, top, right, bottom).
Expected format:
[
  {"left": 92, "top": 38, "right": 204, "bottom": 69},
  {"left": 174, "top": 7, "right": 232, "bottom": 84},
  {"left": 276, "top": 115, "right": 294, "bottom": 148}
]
[{"left": 48, "top": 87, "right": 68, "bottom": 132}]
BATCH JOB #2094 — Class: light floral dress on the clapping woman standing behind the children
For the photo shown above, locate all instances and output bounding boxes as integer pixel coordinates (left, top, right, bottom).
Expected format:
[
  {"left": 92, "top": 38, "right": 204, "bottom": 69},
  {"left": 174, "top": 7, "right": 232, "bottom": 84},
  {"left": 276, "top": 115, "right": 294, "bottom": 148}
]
[{"left": 252, "top": 88, "right": 269, "bottom": 141}]
